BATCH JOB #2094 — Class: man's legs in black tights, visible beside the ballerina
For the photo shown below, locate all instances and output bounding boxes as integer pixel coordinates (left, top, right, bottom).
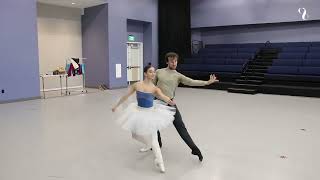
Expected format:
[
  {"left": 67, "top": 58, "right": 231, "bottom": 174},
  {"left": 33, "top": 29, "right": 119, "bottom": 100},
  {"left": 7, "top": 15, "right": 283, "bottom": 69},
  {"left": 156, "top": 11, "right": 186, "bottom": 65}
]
[{"left": 158, "top": 106, "right": 203, "bottom": 161}]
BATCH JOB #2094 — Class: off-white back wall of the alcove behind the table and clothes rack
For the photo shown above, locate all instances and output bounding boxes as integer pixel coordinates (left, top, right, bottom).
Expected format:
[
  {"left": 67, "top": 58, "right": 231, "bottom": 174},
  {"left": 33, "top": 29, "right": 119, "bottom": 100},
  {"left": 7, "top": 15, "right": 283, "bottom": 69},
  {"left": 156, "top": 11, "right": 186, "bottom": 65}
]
[{"left": 38, "top": 3, "right": 82, "bottom": 89}]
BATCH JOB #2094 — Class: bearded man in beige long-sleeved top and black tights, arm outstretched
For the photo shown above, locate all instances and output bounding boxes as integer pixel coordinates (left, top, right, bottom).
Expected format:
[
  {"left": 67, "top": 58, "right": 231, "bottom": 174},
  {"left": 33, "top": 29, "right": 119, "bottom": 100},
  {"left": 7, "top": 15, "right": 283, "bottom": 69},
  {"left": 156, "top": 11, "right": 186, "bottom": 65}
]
[{"left": 155, "top": 52, "right": 218, "bottom": 161}]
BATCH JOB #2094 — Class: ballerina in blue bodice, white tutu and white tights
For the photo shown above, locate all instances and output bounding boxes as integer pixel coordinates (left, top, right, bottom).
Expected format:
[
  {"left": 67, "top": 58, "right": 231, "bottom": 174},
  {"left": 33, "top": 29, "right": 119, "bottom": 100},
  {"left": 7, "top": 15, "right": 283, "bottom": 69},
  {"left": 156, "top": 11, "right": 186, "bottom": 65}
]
[{"left": 112, "top": 64, "right": 175, "bottom": 173}]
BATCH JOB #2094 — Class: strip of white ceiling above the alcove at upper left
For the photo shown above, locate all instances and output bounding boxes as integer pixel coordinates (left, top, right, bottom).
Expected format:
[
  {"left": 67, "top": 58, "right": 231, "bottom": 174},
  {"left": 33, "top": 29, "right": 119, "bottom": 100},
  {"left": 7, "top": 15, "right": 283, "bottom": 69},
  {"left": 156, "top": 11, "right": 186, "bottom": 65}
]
[{"left": 37, "top": 0, "right": 106, "bottom": 8}]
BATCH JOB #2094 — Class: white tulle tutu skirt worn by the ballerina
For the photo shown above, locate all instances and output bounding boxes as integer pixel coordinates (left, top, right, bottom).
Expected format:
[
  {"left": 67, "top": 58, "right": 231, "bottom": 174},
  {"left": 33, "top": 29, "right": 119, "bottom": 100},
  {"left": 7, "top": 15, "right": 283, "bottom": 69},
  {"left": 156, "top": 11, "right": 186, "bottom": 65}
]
[{"left": 116, "top": 100, "right": 176, "bottom": 135}]
